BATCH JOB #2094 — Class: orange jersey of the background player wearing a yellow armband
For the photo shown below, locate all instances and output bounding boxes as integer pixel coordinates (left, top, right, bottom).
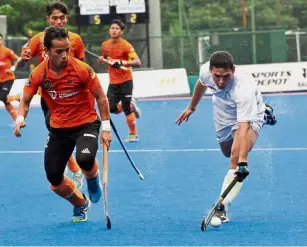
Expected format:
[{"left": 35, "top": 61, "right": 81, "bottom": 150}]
[{"left": 101, "top": 38, "right": 136, "bottom": 84}]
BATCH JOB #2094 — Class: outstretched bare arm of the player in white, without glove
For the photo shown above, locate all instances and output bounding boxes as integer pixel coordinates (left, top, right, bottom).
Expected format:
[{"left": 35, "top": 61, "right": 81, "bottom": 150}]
[{"left": 175, "top": 79, "right": 208, "bottom": 125}]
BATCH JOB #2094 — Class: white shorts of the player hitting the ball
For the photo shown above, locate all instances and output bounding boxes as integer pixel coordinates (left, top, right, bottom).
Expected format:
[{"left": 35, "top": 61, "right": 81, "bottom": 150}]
[{"left": 216, "top": 121, "right": 264, "bottom": 142}]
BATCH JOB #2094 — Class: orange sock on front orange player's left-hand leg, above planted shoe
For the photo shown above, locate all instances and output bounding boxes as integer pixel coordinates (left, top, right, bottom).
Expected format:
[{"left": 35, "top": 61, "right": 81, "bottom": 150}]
[{"left": 50, "top": 176, "right": 85, "bottom": 206}]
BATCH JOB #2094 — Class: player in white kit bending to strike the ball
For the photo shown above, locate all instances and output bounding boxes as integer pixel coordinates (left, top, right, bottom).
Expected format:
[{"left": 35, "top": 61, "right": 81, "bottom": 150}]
[{"left": 176, "top": 51, "right": 276, "bottom": 222}]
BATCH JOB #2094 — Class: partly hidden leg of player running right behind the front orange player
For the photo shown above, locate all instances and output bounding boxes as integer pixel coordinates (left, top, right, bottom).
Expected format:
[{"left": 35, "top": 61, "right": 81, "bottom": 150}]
[{"left": 41, "top": 104, "right": 83, "bottom": 189}]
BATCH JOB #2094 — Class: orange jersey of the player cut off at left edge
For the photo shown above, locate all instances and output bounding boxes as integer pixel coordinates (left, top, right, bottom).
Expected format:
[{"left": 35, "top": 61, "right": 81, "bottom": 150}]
[{"left": 0, "top": 45, "right": 18, "bottom": 83}]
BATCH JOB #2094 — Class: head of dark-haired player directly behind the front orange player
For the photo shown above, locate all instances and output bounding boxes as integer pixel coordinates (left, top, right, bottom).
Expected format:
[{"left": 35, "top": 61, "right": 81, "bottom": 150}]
[{"left": 45, "top": 1, "right": 68, "bottom": 27}]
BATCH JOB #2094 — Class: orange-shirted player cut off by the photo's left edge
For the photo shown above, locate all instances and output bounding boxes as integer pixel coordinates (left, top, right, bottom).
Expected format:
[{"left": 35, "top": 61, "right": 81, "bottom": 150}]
[{"left": 0, "top": 34, "right": 20, "bottom": 121}]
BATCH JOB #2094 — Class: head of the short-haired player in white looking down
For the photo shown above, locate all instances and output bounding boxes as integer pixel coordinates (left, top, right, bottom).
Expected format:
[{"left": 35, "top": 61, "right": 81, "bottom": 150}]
[{"left": 210, "top": 51, "right": 235, "bottom": 89}]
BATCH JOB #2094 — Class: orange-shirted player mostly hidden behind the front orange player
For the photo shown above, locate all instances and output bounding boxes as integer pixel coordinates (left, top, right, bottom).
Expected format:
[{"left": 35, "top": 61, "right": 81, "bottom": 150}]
[{"left": 21, "top": 1, "right": 86, "bottom": 188}]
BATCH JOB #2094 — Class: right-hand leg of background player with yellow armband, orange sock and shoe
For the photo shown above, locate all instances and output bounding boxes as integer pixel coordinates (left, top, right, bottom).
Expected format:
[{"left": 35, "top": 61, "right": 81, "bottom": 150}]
[{"left": 120, "top": 81, "right": 139, "bottom": 142}]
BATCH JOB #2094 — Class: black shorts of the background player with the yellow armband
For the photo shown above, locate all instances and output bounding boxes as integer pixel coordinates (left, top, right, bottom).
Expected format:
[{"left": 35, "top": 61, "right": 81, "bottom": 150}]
[{"left": 107, "top": 80, "right": 133, "bottom": 115}]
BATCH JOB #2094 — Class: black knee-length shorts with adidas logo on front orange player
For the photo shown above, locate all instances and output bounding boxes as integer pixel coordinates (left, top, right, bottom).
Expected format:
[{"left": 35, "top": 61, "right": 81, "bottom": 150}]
[{"left": 44, "top": 117, "right": 101, "bottom": 186}]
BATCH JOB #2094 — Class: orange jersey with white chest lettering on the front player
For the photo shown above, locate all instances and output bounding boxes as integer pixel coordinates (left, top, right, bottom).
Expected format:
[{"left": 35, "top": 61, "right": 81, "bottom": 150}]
[{"left": 24, "top": 57, "right": 100, "bottom": 128}]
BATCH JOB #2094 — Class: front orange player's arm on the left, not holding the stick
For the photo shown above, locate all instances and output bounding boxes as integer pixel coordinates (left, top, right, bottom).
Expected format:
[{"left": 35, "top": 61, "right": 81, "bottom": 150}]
[{"left": 14, "top": 75, "right": 39, "bottom": 137}]
